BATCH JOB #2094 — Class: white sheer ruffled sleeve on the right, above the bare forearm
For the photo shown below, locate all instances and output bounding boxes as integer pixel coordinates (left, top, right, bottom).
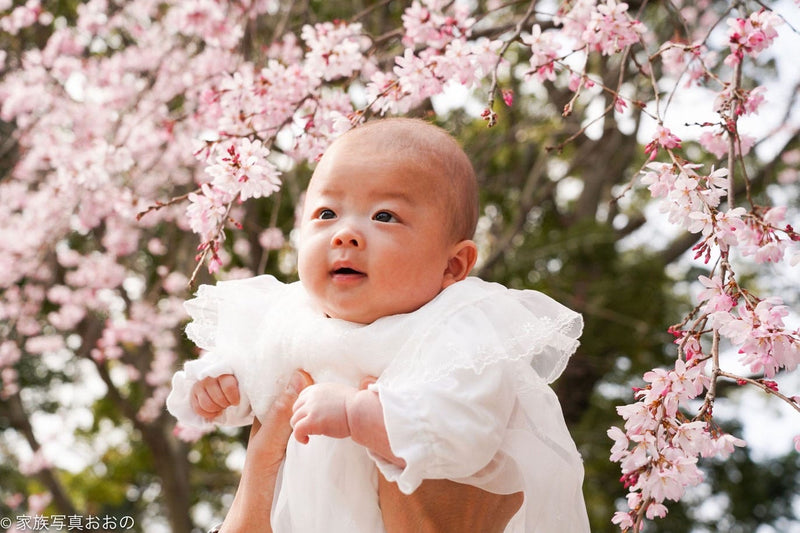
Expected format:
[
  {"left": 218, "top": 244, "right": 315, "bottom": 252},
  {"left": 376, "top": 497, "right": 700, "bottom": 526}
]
[{"left": 372, "top": 278, "right": 583, "bottom": 493}]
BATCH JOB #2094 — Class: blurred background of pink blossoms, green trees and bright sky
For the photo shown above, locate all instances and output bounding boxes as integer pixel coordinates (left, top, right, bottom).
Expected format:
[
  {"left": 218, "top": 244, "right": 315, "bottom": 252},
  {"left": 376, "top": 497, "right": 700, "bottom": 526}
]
[{"left": 0, "top": 0, "right": 800, "bottom": 533}]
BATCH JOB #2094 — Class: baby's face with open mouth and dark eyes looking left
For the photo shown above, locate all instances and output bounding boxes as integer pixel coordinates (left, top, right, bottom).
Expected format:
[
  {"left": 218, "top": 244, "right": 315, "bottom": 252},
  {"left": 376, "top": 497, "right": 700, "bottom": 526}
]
[{"left": 298, "top": 141, "right": 454, "bottom": 324}]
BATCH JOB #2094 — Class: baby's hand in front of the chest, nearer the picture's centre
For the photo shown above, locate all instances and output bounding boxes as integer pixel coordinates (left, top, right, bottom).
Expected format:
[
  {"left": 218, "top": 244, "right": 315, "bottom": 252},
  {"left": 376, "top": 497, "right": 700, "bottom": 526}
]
[{"left": 291, "top": 383, "right": 358, "bottom": 444}]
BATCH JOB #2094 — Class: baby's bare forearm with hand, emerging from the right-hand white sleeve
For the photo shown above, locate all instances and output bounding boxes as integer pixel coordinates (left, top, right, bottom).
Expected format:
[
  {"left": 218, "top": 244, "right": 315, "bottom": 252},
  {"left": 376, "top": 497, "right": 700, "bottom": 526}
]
[{"left": 291, "top": 381, "right": 405, "bottom": 468}]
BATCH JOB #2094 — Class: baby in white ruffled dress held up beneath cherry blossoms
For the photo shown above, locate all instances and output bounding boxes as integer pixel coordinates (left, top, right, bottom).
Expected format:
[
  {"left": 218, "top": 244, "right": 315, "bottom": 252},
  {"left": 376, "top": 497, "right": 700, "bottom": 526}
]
[{"left": 167, "top": 119, "right": 589, "bottom": 533}]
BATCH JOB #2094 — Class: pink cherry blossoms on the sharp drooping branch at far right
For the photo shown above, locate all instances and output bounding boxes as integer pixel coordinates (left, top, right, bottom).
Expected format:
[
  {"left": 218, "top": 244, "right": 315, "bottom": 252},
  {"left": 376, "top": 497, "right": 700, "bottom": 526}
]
[{"left": 608, "top": 2, "right": 800, "bottom": 531}]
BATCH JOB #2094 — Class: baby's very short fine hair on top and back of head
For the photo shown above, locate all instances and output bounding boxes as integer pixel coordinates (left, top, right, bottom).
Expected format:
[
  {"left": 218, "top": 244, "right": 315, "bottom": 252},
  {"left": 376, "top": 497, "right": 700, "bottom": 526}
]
[{"left": 342, "top": 118, "right": 478, "bottom": 241}]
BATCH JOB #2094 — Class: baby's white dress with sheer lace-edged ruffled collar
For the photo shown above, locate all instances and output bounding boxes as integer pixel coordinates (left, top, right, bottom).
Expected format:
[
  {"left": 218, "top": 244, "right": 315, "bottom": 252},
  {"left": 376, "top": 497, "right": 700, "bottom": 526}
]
[{"left": 167, "top": 276, "right": 589, "bottom": 533}]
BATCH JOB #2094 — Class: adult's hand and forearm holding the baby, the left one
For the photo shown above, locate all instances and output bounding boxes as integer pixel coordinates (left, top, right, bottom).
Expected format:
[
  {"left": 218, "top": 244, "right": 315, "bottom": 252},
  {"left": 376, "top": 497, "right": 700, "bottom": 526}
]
[{"left": 219, "top": 370, "right": 314, "bottom": 533}]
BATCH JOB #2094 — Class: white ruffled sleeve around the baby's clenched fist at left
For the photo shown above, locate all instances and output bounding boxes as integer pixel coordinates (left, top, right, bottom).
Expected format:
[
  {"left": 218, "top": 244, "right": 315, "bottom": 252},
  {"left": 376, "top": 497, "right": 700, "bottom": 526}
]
[{"left": 167, "top": 276, "right": 288, "bottom": 430}]
